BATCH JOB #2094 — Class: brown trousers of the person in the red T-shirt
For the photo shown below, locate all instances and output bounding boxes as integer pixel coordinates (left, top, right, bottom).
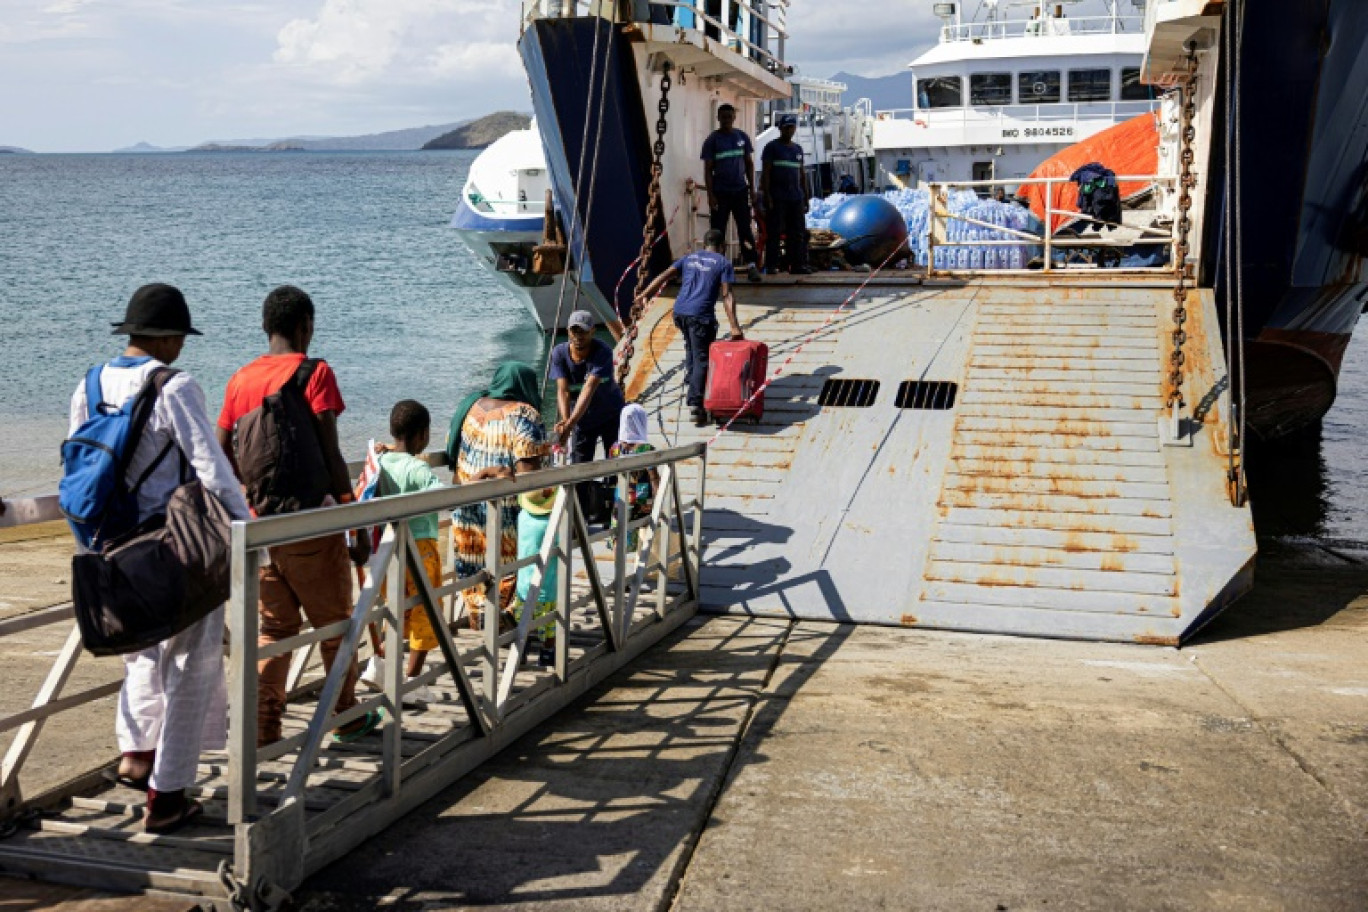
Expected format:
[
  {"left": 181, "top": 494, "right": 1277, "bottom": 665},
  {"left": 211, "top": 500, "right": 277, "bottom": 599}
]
[{"left": 257, "top": 535, "right": 357, "bottom": 745}]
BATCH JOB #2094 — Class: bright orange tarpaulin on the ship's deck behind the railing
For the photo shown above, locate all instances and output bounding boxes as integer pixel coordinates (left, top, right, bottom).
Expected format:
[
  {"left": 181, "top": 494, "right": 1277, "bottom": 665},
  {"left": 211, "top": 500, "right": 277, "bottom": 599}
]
[{"left": 1016, "top": 111, "right": 1159, "bottom": 232}]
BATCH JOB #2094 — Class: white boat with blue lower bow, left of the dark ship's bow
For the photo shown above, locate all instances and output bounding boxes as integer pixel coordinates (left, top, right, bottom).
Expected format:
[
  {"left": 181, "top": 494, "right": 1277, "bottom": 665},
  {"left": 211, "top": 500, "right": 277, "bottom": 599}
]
[{"left": 451, "top": 123, "right": 573, "bottom": 330}]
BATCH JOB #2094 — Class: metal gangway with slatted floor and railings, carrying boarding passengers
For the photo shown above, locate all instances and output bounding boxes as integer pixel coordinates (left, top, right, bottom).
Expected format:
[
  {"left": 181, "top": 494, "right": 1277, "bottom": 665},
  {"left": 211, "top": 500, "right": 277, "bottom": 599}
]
[{"left": 0, "top": 444, "right": 707, "bottom": 909}]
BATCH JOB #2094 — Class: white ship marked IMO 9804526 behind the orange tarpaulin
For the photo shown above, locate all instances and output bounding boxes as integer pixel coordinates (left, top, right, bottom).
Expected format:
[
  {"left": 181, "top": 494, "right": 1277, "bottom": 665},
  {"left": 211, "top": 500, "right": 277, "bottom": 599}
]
[{"left": 874, "top": 0, "right": 1159, "bottom": 187}]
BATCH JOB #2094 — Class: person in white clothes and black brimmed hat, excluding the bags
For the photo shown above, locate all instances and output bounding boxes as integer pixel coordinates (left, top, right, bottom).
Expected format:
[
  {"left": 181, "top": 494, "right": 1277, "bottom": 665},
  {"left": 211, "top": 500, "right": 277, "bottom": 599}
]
[{"left": 71, "top": 284, "right": 249, "bottom": 833}]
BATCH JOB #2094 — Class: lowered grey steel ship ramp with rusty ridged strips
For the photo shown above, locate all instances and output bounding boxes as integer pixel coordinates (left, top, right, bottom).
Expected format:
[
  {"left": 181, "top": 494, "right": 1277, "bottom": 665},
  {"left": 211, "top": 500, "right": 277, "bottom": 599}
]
[{"left": 629, "top": 273, "right": 1254, "bottom": 644}]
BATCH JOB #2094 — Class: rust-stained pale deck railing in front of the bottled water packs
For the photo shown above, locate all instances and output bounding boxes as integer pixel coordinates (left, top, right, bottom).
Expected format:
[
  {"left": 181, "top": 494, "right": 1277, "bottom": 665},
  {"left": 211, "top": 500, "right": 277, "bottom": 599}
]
[{"left": 923, "top": 175, "right": 1181, "bottom": 275}]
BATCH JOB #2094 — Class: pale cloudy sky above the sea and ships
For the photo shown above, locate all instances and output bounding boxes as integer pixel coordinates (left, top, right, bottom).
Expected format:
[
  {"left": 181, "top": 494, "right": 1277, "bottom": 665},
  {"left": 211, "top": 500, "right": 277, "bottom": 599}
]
[{"left": 0, "top": 0, "right": 1116, "bottom": 152}]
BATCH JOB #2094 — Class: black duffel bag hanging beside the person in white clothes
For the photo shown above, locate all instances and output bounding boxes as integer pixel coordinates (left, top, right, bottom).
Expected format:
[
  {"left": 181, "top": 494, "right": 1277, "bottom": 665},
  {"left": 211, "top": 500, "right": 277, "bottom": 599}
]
[{"left": 71, "top": 480, "right": 233, "bottom": 655}]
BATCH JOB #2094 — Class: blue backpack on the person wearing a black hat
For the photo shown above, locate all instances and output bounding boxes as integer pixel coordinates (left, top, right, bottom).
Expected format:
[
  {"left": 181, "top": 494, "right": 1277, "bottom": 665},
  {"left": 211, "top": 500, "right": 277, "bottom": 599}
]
[{"left": 57, "top": 365, "right": 178, "bottom": 551}]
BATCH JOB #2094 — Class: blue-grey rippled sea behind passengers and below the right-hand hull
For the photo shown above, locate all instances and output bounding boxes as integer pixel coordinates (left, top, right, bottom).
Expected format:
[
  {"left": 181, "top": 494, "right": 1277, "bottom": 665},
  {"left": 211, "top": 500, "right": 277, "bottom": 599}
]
[{"left": 0, "top": 152, "right": 1368, "bottom": 541}]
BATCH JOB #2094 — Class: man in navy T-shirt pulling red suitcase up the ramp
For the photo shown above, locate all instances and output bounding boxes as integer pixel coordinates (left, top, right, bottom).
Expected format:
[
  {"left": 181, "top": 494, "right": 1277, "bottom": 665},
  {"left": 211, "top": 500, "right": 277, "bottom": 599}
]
[{"left": 637, "top": 228, "right": 746, "bottom": 428}]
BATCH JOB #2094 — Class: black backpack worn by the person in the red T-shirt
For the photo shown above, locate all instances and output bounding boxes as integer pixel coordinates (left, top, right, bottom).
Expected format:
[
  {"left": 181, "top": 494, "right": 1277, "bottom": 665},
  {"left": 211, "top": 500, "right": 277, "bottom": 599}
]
[{"left": 233, "top": 358, "right": 331, "bottom": 515}]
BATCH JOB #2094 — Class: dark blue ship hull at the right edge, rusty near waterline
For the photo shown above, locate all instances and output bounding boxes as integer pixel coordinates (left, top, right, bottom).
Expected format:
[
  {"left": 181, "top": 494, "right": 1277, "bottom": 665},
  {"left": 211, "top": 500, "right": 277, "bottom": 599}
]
[{"left": 1225, "top": 0, "right": 1368, "bottom": 438}]
